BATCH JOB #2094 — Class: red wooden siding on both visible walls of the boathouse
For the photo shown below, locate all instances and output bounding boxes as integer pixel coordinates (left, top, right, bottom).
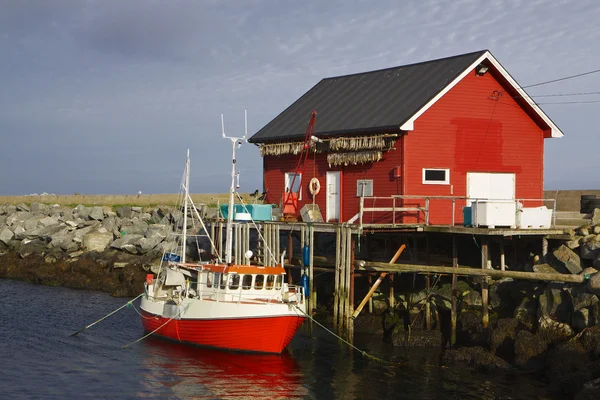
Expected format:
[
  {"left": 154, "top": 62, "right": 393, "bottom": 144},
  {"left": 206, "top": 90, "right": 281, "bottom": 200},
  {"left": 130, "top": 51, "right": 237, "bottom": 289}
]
[{"left": 264, "top": 67, "right": 544, "bottom": 224}]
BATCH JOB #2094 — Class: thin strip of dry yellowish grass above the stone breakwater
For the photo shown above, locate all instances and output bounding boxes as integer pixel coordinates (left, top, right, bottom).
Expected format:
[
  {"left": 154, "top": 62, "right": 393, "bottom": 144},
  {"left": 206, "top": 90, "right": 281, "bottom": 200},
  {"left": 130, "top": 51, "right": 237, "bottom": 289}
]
[{"left": 0, "top": 193, "right": 254, "bottom": 207}]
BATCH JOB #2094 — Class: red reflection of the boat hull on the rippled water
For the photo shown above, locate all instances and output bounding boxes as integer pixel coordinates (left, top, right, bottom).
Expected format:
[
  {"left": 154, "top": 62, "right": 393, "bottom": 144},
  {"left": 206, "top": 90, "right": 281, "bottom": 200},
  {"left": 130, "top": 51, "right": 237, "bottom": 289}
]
[{"left": 144, "top": 338, "right": 308, "bottom": 399}]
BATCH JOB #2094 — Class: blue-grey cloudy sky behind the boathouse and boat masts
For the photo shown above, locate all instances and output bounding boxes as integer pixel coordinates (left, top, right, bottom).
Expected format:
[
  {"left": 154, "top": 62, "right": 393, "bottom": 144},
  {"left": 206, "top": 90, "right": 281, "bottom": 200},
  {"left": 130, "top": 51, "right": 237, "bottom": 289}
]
[{"left": 0, "top": 0, "right": 600, "bottom": 195}]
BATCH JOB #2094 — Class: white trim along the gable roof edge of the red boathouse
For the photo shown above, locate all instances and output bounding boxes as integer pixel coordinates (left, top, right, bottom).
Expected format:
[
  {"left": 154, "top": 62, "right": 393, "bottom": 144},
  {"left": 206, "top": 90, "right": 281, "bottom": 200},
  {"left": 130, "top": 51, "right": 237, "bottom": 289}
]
[{"left": 400, "top": 51, "right": 564, "bottom": 137}]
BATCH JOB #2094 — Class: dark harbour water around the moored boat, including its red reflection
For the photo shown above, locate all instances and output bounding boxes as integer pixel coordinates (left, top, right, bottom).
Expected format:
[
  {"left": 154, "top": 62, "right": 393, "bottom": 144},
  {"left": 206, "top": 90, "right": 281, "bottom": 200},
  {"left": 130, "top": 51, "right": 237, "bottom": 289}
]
[{"left": 0, "top": 279, "right": 551, "bottom": 399}]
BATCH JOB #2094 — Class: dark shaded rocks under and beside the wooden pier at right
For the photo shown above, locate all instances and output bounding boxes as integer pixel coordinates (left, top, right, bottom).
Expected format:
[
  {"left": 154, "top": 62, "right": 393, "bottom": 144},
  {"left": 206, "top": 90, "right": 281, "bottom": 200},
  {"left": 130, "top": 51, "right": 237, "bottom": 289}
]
[{"left": 374, "top": 209, "right": 600, "bottom": 399}]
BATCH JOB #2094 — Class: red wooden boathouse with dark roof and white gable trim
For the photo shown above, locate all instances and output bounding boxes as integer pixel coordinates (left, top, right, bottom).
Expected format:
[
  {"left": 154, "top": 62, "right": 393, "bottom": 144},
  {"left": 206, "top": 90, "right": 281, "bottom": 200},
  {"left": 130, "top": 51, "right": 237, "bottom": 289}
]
[{"left": 249, "top": 50, "right": 563, "bottom": 225}]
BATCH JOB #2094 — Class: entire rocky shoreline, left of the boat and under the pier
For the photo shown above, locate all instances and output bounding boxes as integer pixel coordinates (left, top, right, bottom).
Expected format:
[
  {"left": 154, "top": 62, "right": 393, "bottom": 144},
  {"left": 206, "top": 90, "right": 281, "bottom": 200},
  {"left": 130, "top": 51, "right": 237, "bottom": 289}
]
[{"left": 0, "top": 203, "right": 600, "bottom": 399}]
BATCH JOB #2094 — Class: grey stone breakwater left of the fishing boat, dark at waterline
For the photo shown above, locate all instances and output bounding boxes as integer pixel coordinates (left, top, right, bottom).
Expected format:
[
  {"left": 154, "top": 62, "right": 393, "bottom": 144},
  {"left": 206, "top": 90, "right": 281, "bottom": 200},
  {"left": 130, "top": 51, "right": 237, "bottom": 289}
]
[{"left": 0, "top": 203, "right": 199, "bottom": 296}]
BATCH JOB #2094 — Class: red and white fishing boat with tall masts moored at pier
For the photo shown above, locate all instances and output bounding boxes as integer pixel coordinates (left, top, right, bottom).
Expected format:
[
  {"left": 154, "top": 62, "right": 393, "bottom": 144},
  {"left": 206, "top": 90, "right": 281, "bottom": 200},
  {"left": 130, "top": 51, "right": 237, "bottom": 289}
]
[{"left": 140, "top": 116, "right": 306, "bottom": 353}]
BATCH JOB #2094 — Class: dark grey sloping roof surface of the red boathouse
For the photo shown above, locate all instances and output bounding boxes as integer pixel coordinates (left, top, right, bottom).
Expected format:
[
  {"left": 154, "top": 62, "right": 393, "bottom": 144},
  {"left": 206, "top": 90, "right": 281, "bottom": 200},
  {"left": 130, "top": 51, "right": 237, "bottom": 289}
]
[{"left": 248, "top": 50, "right": 487, "bottom": 143}]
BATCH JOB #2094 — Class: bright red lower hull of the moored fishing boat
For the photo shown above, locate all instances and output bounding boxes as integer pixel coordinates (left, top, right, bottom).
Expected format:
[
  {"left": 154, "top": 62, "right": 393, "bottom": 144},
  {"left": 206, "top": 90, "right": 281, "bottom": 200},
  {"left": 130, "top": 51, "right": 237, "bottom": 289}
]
[{"left": 142, "top": 311, "right": 304, "bottom": 353}]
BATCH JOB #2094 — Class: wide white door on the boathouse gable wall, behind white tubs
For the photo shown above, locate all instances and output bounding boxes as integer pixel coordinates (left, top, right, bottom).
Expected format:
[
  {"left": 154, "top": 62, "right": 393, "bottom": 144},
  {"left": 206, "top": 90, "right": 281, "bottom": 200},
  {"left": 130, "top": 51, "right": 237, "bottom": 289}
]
[{"left": 467, "top": 172, "right": 515, "bottom": 205}]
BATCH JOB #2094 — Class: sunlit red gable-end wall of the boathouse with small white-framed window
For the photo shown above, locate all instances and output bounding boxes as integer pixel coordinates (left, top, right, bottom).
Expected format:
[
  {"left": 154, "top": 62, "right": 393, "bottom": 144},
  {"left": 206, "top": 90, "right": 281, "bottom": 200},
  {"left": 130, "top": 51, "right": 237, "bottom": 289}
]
[{"left": 405, "top": 72, "right": 544, "bottom": 224}]
